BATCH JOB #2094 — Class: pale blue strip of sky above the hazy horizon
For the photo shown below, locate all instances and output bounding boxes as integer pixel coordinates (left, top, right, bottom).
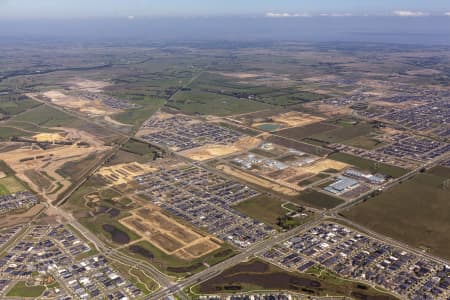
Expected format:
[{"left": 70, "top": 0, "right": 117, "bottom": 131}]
[{"left": 0, "top": 0, "right": 450, "bottom": 18}]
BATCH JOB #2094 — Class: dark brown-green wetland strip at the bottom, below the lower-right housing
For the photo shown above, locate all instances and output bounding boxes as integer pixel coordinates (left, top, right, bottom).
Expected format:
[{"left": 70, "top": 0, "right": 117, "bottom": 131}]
[{"left": 193, "top": 260, "right": 396, "bottom": 300}]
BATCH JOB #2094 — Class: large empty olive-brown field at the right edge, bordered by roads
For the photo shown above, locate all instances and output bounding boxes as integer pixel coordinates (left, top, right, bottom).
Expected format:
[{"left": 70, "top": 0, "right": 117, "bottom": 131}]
[{"left": 344, "top": 168, "right": 450, "bottom": 258}]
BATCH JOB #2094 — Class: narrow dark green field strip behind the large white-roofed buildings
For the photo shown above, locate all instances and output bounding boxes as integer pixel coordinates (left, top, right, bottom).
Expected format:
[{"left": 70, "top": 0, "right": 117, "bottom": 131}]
[{"left": 328, "top": 152, "right": 408, "bottom": 178}]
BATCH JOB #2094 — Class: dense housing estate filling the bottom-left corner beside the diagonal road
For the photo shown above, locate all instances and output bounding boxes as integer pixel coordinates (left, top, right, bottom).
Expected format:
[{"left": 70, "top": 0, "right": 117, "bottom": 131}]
[{"left": 0, "top": 225, "right": 141, "bottom": 300}]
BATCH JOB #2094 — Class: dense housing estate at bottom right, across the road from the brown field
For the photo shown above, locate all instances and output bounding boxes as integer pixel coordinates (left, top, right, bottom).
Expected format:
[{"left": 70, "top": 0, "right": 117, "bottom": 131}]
[{"left": 262, "top": 223, "right": 450, "bottom": 300}]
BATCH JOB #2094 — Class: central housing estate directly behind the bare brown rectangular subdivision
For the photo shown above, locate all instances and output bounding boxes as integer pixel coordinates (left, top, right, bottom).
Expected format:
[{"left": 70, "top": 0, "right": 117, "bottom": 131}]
[{"left": 135, "top": 166, "right": 273, "bottom": 247}]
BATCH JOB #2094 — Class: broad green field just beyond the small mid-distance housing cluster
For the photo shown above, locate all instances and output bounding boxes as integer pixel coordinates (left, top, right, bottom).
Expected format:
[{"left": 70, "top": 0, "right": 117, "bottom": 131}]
[{"left": 167, "top": 90, "right": 273, "bottom": 116}]
